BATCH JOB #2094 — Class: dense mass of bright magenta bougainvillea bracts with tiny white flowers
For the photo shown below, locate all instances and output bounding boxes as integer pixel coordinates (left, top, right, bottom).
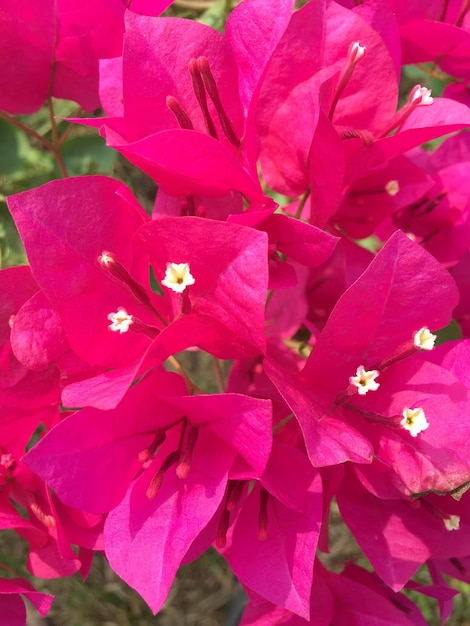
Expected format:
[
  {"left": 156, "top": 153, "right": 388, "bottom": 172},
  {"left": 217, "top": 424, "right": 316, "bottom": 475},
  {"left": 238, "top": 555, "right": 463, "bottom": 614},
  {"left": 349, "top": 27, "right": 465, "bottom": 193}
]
[{"left": 0, "top": 0, "right": 470, "bottom": 626}]
